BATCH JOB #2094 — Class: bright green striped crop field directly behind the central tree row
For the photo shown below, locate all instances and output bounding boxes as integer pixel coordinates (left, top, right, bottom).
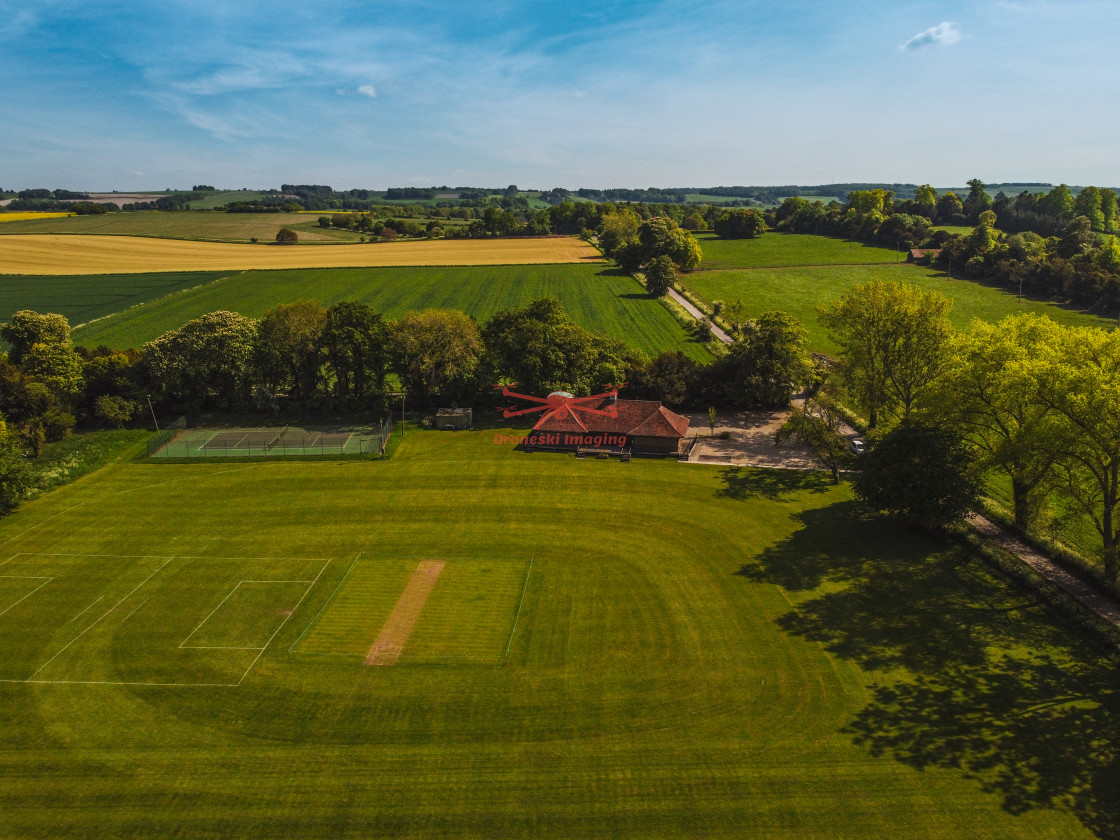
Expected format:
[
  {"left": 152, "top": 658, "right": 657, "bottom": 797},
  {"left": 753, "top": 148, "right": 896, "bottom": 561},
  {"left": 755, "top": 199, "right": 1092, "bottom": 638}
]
[{"left": 74, "top": 264, "right": 711, "bottom": 361}]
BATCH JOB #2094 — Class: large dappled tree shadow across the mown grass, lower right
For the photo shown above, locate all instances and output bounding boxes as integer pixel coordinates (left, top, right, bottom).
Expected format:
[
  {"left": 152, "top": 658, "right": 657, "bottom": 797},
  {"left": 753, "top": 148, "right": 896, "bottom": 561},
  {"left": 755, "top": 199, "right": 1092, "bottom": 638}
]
[{"left": 739, "top": 503, "right": 1120, "bottom": 839}]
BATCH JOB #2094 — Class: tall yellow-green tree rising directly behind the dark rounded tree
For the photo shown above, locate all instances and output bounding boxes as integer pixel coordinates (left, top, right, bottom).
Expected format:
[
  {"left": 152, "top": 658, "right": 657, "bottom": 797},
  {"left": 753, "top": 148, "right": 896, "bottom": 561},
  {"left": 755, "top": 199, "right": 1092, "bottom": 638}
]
[{"left": 820, "top": 280, "right": 952, "bottom": 428}]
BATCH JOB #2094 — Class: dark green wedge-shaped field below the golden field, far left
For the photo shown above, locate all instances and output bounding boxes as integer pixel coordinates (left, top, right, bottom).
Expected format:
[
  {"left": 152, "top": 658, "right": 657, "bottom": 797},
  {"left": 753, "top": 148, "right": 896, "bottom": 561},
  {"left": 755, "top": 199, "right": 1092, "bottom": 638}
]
[{"left": 0, "top": 271, "right": 226, "bottom": 326}]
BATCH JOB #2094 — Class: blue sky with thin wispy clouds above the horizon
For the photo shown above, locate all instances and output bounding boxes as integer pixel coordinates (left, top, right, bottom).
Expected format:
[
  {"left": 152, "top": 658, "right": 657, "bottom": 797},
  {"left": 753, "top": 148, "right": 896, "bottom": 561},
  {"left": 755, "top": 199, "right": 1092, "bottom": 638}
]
[{"left": 0, "top": 0, "right": 1120, "bottom": 190}]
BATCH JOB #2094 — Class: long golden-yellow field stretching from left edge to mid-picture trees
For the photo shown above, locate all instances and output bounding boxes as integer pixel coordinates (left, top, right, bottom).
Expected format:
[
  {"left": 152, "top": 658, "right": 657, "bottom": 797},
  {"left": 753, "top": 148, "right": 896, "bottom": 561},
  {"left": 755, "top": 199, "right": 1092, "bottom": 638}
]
[{"left": 0, "top": 234, "right": 601, "bottom": 274}]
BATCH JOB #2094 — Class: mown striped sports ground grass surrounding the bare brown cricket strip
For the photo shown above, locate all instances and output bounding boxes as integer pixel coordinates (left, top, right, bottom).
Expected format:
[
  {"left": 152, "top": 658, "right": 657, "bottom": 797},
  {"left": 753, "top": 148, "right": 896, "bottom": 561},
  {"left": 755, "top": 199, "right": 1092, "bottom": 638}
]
[{"left": 0, "top": 432, "right": 1120, "bottom": 840}]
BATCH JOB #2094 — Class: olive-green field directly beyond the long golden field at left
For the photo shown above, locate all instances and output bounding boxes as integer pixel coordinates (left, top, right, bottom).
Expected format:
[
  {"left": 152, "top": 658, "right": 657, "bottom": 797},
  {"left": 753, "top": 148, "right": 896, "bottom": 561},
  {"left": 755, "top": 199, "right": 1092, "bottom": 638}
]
[{"left": 0, "top": 211, "right": 360, "bottom": 244}]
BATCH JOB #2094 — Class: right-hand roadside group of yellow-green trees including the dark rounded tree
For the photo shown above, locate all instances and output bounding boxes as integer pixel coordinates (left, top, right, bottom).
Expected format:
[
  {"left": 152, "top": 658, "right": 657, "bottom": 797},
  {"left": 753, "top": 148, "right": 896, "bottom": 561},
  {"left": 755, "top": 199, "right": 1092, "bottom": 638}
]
[{"left": 784, "top": 281, "right": 1120, "bottom": 585}]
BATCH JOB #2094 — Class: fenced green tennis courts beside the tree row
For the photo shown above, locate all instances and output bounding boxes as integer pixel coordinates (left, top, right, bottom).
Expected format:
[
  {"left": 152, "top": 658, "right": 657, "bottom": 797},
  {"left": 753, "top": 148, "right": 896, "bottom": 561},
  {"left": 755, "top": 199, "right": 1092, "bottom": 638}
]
[{"left": 148, "top": 424, "right": 386, "bottom": 458}]
